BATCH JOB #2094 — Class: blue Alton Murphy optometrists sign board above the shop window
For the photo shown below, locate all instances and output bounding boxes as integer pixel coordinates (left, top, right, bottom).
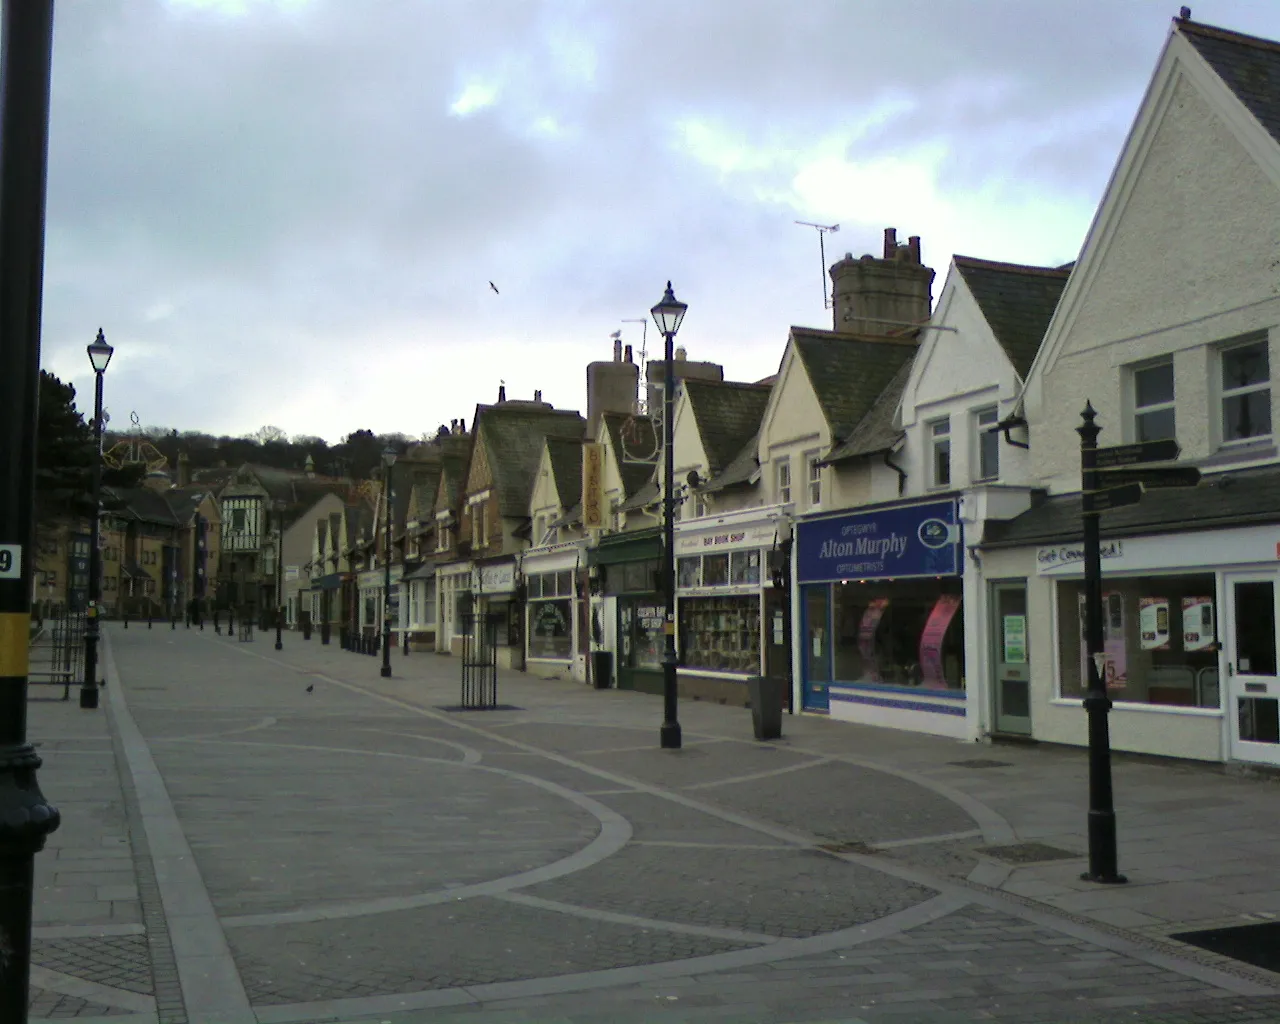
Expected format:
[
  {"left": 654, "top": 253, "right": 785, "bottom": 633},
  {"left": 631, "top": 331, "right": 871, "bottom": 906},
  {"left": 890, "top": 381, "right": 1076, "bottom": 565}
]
[{"left": 797, "top": 500, "right": 961, "bottom": 582}]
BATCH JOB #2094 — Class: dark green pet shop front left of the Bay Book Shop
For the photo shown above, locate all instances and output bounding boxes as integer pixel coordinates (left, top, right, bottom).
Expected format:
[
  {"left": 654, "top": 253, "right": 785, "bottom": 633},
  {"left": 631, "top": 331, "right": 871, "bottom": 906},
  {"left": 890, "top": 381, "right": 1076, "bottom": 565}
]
[{"left": 591, "top": 527, "right": 667, "bottom": 694}]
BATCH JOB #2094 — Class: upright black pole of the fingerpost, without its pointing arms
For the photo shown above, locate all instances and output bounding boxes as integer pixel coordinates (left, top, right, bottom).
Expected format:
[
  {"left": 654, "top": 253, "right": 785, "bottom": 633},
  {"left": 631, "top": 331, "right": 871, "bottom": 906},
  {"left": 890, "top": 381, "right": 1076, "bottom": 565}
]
[{"left": 1076, "top": 402, "right": 1128, "bottom": 884}]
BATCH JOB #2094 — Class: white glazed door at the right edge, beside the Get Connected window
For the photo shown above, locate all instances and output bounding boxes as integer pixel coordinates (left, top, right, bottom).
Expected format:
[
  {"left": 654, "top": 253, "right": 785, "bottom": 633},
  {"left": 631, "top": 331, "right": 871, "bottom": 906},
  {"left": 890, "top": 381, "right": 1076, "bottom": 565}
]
[{"left": 1224, "top": 573, "right": 1280, "bottom": 765}]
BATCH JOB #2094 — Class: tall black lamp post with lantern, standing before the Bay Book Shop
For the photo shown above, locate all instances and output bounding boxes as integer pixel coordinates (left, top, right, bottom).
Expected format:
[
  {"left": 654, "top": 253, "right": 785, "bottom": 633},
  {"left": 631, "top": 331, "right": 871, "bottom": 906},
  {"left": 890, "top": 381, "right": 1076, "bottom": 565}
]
[{"left": 650, "top": 280, "right": 689, "bottom": 750}]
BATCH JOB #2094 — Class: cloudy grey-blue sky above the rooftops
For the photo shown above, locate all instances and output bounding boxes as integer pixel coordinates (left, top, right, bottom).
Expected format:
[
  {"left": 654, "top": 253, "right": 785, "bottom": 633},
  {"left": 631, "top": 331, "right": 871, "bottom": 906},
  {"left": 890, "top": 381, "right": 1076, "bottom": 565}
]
[{"left": 35, "top": 0, "right": 1280, "bottom": 442}]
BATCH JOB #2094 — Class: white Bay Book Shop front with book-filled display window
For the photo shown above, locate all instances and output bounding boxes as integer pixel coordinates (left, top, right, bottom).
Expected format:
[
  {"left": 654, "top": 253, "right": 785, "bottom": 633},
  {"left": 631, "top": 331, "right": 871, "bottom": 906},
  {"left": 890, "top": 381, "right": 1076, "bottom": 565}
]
[{"left": 676, "top": 517, "right": 777, "bottom": 704}]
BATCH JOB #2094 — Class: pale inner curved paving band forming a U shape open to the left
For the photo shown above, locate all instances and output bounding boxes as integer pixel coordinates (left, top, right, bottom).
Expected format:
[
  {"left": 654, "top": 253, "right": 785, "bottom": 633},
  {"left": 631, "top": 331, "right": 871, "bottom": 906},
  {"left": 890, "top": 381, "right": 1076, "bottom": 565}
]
[{"left": 210, "top": 740, "right": 631, "bottom": 928}]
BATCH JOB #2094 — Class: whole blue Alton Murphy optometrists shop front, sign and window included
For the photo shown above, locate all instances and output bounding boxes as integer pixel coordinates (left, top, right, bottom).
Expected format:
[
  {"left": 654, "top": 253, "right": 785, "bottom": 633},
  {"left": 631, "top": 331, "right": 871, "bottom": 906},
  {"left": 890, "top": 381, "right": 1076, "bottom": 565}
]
[{"left": 795, "top": 495, "right": 970, "bottom": 739}]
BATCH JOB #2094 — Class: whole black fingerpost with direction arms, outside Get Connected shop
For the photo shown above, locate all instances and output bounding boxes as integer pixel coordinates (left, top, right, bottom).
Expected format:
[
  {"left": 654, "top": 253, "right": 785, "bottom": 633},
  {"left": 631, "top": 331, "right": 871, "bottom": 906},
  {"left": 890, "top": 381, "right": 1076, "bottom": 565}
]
[{"left": 1076, "top": 402, "right": 1199, "bottom": 884}]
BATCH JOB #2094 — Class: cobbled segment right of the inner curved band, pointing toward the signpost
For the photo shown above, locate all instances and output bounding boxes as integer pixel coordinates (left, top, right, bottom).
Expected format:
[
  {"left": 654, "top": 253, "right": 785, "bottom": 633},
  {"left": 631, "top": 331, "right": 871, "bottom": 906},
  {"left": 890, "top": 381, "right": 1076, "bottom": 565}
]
[{"left": 525, "top": 846, "right": 934, "bottom": 938}]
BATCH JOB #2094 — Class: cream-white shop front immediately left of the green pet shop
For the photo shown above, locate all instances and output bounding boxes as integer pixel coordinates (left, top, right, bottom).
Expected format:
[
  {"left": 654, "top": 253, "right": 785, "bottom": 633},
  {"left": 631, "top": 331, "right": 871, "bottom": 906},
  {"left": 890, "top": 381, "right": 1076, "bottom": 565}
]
[{"left": 521, "top": 541, "right": 588, "bottom": 681}]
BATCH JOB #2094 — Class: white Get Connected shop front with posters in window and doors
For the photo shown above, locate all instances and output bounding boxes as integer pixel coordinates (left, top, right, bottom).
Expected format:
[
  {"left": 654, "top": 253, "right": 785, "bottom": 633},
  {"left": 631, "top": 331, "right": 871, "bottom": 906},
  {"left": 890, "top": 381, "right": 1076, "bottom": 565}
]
[{"left": 983, "top": 519, "right": 1280, "bottom": 767}]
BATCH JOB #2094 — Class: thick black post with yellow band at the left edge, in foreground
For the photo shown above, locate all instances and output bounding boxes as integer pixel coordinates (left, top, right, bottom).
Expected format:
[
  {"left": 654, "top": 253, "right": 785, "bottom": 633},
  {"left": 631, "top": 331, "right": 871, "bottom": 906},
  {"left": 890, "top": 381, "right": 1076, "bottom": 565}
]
[{"left": 0, "top": 0, "right": 60, "bottom": 1024}]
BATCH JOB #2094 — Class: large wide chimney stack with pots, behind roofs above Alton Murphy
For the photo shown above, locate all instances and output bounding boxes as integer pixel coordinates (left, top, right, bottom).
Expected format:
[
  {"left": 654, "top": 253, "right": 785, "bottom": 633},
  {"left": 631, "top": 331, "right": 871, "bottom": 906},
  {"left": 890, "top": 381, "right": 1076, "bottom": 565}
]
[{"left": 831, "top": 228, "right": 933, "bottom": 335}]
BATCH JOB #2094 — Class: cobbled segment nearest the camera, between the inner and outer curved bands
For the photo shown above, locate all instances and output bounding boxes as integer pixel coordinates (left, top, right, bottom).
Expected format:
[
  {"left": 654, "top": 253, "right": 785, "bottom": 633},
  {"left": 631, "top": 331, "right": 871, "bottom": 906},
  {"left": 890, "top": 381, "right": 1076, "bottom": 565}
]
[{"left": 227, "top": 899, "right": 741, "bottom": 1004}]
